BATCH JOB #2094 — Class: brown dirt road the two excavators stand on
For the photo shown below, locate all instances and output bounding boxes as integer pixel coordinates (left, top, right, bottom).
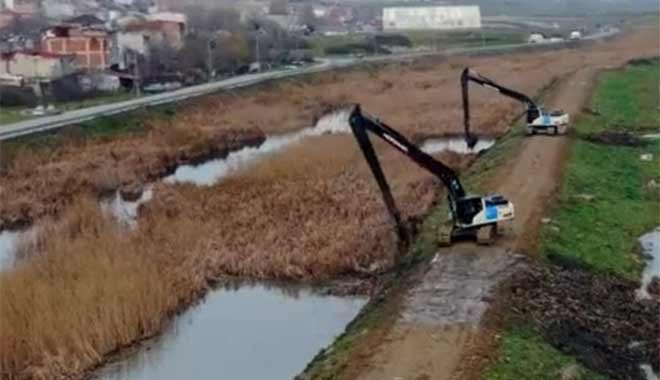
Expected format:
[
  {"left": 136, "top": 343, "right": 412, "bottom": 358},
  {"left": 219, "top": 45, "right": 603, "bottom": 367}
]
[{"left": 350, "top": 31, "right": 656, "bottom": 380}]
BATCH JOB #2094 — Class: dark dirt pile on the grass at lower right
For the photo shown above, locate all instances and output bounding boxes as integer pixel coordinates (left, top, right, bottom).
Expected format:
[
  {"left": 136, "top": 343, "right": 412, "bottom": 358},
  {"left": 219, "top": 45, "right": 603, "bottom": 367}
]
[{"left": 511, "top": 265, "right": 660, "bottom": 380}]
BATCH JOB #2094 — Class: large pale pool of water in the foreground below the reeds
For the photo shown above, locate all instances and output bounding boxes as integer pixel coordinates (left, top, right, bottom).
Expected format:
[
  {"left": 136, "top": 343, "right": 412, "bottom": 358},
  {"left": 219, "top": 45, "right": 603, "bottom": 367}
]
[{"left": 95, "top": 285, "right": 366, "bottom": 380}]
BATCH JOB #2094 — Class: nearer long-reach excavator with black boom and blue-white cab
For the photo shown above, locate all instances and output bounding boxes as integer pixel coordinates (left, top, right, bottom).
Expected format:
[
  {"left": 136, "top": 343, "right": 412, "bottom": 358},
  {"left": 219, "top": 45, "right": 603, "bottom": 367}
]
[{"left": 349, "top": 105, "right": 514, "bottom": 244}]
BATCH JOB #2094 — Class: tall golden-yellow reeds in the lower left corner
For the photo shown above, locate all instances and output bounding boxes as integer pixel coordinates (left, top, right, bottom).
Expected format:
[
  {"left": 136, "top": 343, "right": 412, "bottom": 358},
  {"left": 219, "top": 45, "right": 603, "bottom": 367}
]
[{"left": 0, "top": 200, "right": 214, "bottom": 379}]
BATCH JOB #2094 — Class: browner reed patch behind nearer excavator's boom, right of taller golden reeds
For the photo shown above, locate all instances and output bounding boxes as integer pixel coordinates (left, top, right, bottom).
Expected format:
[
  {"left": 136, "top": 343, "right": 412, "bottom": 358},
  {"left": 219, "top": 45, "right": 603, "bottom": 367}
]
[{"left": 140, "top": 135, "right": 471, "bottom": 281}]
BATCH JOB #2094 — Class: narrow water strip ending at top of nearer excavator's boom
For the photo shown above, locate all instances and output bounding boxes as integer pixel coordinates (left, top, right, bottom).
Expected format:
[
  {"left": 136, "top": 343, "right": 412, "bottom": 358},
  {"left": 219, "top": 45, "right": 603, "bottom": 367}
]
[{"left": 164, "top": 110, "right": 350, "bottom": 186}]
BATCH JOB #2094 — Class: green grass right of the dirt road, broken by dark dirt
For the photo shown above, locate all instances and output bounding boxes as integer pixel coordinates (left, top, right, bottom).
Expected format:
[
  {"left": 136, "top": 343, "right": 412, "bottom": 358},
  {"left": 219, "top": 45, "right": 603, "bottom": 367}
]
[{"left": 483, "top": 61, "right": 660, "bottom": 380}]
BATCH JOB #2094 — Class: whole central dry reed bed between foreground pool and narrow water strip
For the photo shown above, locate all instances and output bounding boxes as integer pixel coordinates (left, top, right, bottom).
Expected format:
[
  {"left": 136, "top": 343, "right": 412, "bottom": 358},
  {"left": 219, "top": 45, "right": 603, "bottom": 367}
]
[{"left": 0, "top": 136, "right": 469, "bottom": 379}]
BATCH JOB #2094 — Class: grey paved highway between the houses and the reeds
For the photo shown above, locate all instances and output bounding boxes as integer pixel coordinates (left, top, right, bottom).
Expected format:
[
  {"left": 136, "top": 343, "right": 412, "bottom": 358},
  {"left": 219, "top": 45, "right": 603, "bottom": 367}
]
[{"left": 0, "top": 30, "right": 618, "bottom": 141}]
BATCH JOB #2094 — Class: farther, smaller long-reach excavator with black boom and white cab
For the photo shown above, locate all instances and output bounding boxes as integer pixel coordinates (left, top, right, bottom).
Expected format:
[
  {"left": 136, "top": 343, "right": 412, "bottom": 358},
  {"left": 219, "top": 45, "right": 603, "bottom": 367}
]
[{"left": 461, "top": 68, "right": 569, "bottom": 148}]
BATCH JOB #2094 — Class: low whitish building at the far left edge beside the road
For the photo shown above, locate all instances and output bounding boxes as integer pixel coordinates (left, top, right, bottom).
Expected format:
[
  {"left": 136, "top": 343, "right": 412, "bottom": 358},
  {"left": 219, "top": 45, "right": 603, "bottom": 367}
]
[{"left": 0, "top": 51, "right": 76, "bottom": 81}]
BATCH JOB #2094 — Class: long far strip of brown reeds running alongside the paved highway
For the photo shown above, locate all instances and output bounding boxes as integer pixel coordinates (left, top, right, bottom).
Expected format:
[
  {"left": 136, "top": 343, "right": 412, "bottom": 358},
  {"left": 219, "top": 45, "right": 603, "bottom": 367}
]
[{"left": 0, "top": 29, "right": 657, "bottom": 229}]
